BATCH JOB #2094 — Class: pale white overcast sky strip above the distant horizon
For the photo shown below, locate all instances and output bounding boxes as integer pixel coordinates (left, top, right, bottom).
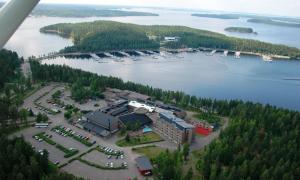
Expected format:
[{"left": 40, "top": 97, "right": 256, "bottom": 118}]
[{"left": 0, "top": 0, "right": 300, "bottom": 17}]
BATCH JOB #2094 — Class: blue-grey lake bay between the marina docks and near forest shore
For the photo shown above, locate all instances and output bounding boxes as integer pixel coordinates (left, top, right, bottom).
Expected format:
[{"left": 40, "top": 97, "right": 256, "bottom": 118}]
[{"left": 44, "top": 52, "right": 300, "bottom": 110}]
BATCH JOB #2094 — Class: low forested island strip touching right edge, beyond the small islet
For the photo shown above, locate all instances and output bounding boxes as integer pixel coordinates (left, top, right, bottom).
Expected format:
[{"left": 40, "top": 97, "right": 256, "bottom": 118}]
[{"left": 247, "top": 18, "right": 300, "bottom": 28}]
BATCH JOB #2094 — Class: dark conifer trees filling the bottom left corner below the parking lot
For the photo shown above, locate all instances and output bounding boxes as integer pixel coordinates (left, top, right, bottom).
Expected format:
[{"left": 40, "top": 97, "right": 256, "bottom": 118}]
[{"left": 0, "top": 136, "right": 79, "bottom": 180}]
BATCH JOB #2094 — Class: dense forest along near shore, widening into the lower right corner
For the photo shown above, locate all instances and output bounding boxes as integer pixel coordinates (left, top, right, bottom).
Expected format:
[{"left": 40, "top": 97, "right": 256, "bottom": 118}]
[{"left": 31, "top": 61, "right": 300, "bottom": 180}]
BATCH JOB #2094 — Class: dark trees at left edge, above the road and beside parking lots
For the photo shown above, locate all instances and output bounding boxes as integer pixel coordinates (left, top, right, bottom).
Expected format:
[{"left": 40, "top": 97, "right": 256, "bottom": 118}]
[{"left": 0, "top": 50, "right": 32, "bottom": 134}]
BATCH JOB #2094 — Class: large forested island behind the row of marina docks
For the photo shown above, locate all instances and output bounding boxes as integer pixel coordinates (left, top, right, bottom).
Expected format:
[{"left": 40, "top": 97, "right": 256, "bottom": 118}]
[{"left": 40, "top": 21, "right": 300, "bottom": 58}]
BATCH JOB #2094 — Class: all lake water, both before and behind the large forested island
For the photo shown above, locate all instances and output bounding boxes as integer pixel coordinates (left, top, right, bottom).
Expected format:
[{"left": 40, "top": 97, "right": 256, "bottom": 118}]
[{"left": 6, "top": 9, "right": 300, "bottom": 110}]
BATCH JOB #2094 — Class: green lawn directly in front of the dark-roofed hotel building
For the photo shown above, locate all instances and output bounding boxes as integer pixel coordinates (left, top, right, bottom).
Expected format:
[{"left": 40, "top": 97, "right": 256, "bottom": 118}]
[{"left": 116, "top": 132, "right": 163, "bottom": 147}]
